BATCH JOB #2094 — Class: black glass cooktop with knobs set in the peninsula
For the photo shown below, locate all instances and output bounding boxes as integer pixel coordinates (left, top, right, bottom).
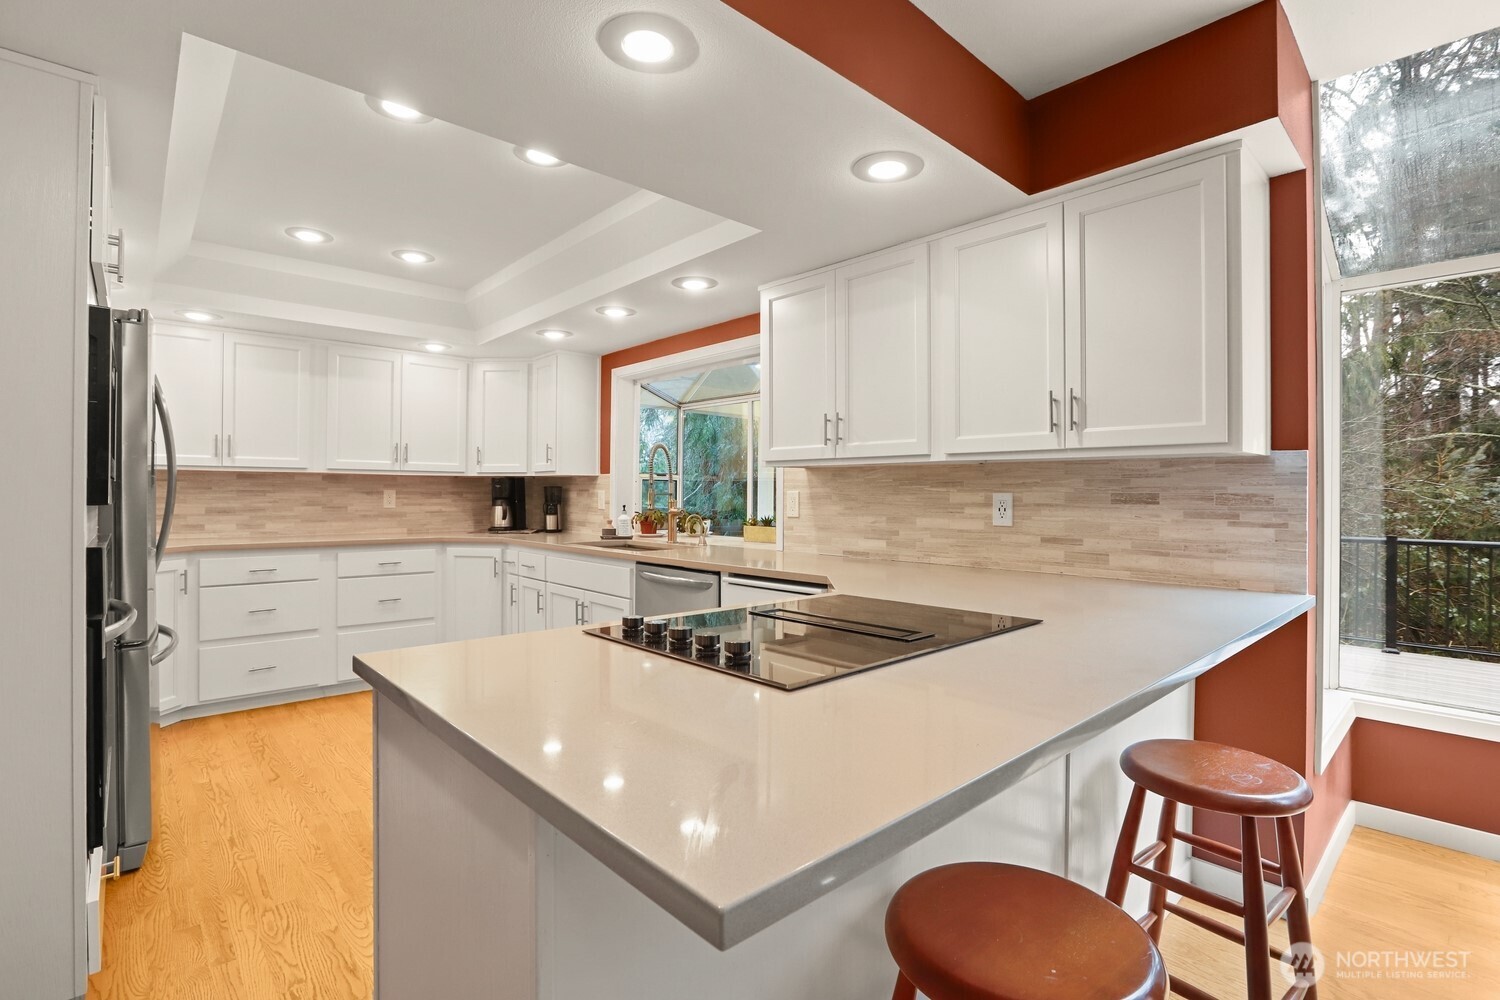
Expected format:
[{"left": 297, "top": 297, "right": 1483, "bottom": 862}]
[{"left": 587, "top": 594, "right": 1041, "bottom": 691}]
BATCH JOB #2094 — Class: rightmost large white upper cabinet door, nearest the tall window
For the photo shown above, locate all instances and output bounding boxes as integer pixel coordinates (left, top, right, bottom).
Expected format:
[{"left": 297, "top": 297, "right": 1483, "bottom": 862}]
[{"left": 1064, "top": 157, "right": 1230, "bottom": 448}]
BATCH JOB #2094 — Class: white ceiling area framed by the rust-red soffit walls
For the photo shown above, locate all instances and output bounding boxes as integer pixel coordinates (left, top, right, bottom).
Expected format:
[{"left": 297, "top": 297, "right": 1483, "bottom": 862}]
[{"left": 912, "top": 0, "right": 1254, "bottom": 99}]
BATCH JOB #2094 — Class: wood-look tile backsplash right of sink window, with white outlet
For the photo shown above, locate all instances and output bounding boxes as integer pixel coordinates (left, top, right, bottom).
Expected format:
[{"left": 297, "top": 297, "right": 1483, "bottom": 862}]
[{"left": 782, "top": 451, "right": 1308, "bottom": 594}]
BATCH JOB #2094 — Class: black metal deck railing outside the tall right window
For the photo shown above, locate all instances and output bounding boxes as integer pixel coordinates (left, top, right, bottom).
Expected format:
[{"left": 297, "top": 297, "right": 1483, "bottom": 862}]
[{"left": 1338, "top": 535, "right": 1500, "bottom": 661}]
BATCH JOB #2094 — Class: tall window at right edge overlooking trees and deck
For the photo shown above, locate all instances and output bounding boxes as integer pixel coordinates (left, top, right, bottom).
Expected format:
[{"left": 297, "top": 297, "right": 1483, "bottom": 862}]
[{"left": 1319, "top": 28, "right": 1500, "bottom": 712}]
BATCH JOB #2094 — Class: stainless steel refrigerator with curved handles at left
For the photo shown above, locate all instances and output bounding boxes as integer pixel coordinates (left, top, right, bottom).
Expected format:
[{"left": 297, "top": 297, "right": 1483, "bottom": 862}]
[{"left": 89, "top": 307, "right": 177, "bottom": 871}]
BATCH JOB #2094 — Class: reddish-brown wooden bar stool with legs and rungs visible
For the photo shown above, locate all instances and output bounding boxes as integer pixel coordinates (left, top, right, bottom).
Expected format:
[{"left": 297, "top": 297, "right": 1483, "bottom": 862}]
[{"left": 1104, "top": 739, "right": 1317, "bottom": 1000}]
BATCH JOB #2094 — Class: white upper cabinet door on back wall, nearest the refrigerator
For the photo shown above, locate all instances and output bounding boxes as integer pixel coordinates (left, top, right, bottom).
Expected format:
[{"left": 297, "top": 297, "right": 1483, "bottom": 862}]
[{"left": 152, "top": 322, "right": 224, "bottom": 466}]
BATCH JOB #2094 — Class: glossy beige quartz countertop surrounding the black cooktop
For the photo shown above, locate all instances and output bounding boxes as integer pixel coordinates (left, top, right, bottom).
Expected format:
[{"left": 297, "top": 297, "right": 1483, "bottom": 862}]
[{"left": 354, "top": 554, "right": 1313, "bottom": 949}]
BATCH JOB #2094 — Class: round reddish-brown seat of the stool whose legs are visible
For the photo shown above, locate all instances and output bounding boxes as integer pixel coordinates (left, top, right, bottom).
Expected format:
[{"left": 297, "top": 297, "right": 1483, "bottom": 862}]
[{"left": 1121, "top": 739, "right": 1313, "bottom": 817}]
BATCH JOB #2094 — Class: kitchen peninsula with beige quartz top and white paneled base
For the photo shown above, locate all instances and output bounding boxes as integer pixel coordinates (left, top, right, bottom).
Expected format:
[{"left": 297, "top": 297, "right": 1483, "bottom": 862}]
[{"left": 356, "top": 558, "right": 1313, "bottom": 1000}]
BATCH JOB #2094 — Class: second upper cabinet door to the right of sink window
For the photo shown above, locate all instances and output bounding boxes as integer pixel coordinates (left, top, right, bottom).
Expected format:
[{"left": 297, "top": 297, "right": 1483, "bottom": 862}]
[{"left": 840, "top": 246, "right": 932, "bottom": 459}]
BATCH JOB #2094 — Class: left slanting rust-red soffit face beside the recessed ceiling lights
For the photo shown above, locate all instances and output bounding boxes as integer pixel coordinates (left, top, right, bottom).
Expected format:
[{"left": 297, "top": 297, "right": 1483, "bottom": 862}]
[{"left": 723, "top": 0, "right": 1032, "bottom": 190}]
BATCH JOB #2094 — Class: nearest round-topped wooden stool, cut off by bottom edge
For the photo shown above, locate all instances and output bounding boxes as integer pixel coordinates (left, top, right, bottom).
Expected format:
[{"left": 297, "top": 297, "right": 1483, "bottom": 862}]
[{"left": 885, "top": 862, "right": 1167, "bottom": 1000}]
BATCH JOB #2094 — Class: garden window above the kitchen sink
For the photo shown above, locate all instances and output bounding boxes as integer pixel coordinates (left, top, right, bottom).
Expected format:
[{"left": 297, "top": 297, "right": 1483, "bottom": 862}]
[{"left": 638, "top": 361, "right": 776, "bottom": 535}]
